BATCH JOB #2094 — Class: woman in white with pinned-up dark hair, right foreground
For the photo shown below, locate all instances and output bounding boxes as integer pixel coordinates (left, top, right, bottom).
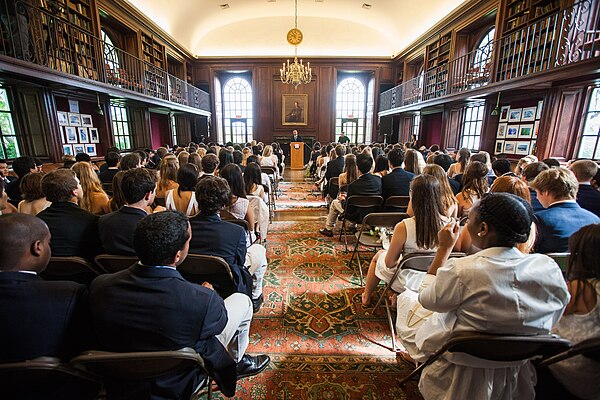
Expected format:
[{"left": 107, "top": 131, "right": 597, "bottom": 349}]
[{"left": 397, "top": 193, "right": 569, "bottom": 400}]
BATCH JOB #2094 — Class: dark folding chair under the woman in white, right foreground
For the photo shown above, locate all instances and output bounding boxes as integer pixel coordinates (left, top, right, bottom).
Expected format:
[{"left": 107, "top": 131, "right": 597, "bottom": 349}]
[{"left": 398, "top": 332, "right": 572, "bottom": 386}]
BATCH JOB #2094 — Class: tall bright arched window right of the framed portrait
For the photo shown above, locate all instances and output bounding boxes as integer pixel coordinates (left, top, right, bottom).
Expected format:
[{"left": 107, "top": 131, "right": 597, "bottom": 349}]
[{"left": 335, "top": 78, "right": 367, "bottom": 143}]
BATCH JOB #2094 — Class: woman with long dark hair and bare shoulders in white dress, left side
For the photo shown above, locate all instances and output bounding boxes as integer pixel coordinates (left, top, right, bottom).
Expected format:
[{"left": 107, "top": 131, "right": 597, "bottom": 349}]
[{"left": 165, "top": 164, "right": 200, "bottom": 217}]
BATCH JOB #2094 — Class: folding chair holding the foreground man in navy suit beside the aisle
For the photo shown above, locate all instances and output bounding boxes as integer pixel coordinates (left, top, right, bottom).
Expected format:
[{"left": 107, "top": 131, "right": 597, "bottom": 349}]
[{"left": 71, "top": 347, "right": 212, "bottom": 399}]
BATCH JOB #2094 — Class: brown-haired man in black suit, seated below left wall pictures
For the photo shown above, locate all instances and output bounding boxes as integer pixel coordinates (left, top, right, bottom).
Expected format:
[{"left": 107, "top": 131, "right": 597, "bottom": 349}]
[{"left": 37, "top": 169, "right": 102, "bottom": 261}]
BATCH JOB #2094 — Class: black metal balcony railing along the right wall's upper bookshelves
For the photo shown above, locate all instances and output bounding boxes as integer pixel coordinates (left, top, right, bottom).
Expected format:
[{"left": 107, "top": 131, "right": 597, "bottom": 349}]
[{"left": 379, "top": 0, "right": 600, "bottom": 112}]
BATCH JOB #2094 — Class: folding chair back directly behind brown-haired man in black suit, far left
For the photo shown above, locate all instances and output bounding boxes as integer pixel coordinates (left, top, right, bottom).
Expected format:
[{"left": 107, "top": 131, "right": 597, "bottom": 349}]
[{"left": 40, "top": 257, "right": 102, "bottom": 285}]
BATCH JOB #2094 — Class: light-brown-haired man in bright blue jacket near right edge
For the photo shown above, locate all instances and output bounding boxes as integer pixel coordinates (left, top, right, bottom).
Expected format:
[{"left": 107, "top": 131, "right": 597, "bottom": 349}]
[{"left": 531, "top": 168, "right": 600, "bottom": 253}]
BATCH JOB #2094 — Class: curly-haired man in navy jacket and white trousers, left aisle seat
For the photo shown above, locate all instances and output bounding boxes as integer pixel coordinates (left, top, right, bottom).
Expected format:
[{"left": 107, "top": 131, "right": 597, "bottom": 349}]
[{"left": 190, "top": 176, "right": 267, "bottom": 312}]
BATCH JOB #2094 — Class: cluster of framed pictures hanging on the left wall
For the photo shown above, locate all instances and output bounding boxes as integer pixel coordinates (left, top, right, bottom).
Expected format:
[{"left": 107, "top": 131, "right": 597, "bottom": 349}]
[{"left": 58, "top": 111, "right": 100, "bottom": 157}]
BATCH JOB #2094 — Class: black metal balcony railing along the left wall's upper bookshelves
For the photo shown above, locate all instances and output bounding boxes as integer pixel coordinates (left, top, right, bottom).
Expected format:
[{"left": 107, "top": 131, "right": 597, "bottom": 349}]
[{"left": 0, "top": 0, "right": 210, "bottom": 111}]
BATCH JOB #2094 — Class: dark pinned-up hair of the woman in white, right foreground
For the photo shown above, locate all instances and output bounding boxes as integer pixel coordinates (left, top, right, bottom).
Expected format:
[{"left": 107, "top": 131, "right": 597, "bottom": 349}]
[{"left": 476, "top": 193, "right": 535, "bottom": 247}]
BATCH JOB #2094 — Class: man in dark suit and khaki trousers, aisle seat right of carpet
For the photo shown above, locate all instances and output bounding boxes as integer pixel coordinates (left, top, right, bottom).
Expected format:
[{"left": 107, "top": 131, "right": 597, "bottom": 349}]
[{"left": 319, "top": 153, "right": 381, "bottom": 237}]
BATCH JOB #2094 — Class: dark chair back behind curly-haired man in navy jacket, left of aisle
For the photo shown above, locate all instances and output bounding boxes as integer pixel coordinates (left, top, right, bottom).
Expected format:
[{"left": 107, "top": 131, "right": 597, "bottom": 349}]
[{"left": 177, "top": 254, "right": 236, "bottom": 298}]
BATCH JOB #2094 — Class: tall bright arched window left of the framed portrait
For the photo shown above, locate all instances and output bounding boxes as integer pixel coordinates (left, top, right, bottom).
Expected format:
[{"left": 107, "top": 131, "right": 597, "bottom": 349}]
[{"left": 223, "top": 77, "right": 253, "bottom": 144}]
